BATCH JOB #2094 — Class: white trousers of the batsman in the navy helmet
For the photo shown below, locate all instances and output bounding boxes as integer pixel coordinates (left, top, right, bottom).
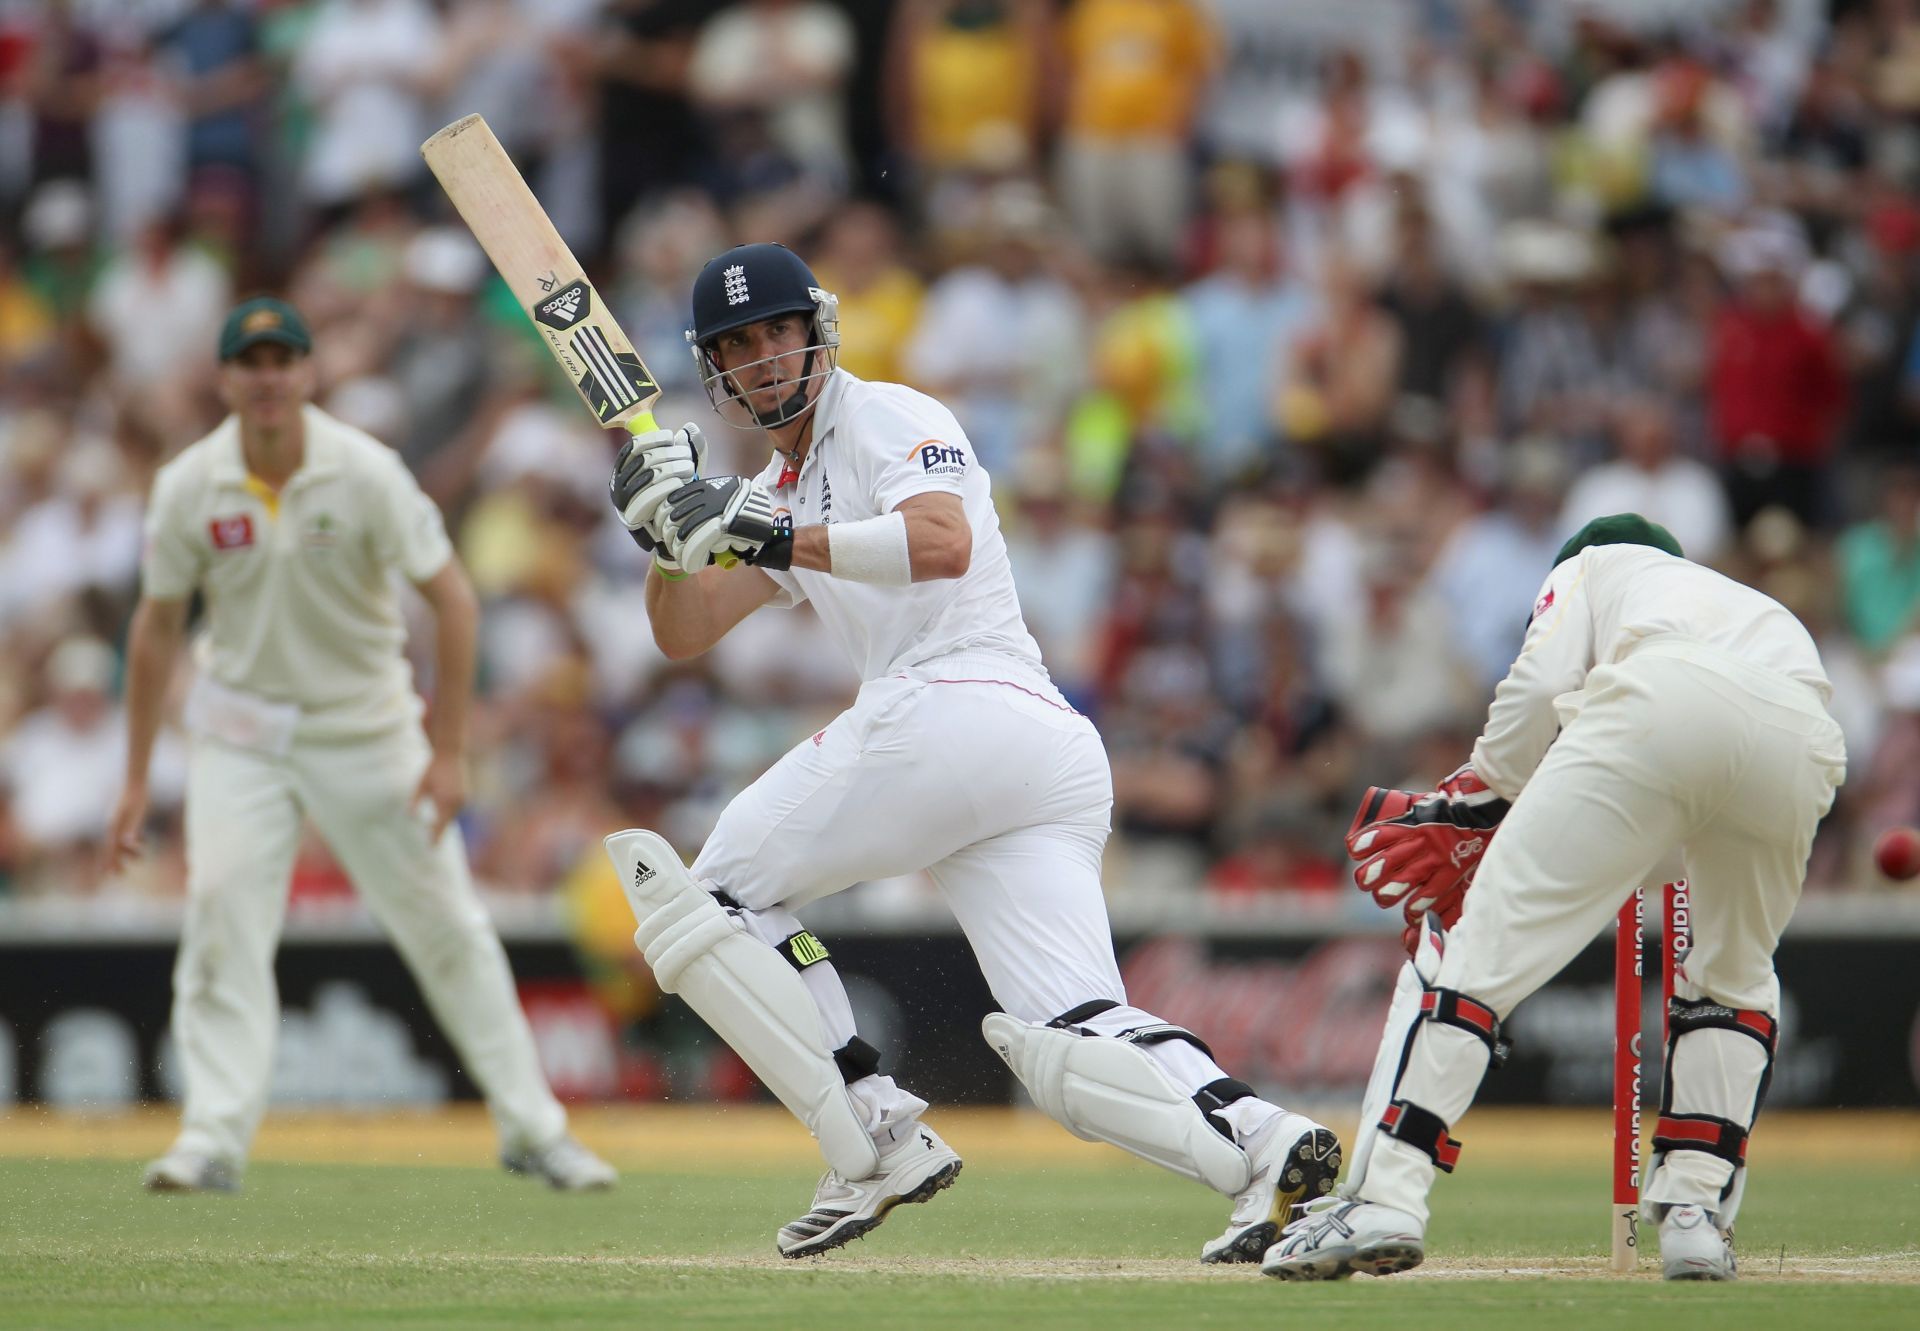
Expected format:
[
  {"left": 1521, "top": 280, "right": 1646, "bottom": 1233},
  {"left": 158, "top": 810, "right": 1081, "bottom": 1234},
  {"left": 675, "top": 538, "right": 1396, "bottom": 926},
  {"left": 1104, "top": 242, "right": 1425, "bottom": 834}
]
[{"left": 693, "top": 655, "right": 1225, "bottom": 1091}]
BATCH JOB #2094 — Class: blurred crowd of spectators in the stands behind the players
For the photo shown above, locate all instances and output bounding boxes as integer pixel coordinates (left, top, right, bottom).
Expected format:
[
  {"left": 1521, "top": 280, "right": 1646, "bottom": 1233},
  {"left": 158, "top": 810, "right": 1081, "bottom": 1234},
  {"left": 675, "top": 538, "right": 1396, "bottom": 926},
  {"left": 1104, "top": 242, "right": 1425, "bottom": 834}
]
[{"left": 0, "top": 0, "right": 1920, "bottom": 914}]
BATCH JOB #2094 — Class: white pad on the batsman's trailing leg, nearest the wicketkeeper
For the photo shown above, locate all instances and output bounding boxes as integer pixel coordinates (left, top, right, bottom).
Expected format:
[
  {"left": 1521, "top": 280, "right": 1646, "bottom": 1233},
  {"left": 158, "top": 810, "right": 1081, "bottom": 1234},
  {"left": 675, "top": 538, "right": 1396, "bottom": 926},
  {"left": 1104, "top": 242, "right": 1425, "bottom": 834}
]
[{"left": 981, "top": 1003, "right": 1254, "bottom": 1197}]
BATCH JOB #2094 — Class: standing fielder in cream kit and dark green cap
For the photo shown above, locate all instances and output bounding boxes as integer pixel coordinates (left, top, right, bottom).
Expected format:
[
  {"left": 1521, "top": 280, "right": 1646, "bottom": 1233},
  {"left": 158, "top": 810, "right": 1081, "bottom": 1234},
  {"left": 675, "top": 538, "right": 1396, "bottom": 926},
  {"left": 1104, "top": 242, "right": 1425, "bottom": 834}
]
[{"left": 111, "top": 298, "right": 614, "bottom": 1191}]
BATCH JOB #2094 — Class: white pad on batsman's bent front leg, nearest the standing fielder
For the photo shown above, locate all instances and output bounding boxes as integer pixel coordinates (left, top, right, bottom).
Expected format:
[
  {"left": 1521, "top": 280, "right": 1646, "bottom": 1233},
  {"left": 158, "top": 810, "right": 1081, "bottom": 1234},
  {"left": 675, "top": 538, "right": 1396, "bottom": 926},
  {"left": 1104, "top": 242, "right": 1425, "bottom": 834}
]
[{"left": 607, "top": 830, "right": 879, "bottom": 1179}]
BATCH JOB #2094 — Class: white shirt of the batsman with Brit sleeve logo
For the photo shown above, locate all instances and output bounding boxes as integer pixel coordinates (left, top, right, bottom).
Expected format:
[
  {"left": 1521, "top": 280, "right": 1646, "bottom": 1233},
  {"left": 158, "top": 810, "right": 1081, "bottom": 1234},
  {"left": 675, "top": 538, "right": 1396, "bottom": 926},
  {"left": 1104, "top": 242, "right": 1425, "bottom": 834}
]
[{"left": 744, "top": 371, "right": 1046, "bottom": 680}]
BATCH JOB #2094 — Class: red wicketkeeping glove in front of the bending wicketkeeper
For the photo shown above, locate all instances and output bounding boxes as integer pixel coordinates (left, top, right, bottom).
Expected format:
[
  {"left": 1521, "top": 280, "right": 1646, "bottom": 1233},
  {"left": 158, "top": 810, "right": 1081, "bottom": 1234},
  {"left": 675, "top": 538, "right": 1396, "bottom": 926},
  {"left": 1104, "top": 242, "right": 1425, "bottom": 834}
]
[{"left": 1346, "top": 766, "right": 1507, "bottom": 926}]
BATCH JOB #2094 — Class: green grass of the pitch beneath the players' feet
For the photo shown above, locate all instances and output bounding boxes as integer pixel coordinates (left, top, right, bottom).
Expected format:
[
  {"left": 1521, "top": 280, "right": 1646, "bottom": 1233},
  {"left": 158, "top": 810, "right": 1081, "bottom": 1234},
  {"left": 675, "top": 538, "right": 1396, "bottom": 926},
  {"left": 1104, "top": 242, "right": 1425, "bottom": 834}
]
[{"left": 0, "top": 1158, "right": 1920, "bottom": 1331}]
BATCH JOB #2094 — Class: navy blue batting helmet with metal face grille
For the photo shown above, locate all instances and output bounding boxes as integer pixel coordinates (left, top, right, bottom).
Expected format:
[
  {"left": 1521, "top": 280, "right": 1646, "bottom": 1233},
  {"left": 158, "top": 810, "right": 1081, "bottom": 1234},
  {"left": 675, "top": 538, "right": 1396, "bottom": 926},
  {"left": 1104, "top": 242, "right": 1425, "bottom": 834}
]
[{"left": 687, "top": 244, "right": 839, "bottom": 428}]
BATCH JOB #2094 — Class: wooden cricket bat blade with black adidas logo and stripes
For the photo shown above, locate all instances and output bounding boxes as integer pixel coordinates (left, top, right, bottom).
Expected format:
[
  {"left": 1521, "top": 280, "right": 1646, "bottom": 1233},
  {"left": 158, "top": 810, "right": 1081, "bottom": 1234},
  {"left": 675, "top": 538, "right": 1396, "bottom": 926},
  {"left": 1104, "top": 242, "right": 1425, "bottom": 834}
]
[{"left": 420, "top": 115, "right": 660, "bottom": 434}]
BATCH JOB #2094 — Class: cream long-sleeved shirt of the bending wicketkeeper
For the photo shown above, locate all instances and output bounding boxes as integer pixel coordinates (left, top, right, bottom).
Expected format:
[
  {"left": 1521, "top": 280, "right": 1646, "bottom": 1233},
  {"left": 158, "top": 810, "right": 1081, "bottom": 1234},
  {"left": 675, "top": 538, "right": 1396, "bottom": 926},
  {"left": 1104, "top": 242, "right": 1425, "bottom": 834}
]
[{"left": 1473, "top": 545, "right": 1834, "bottom": 799}]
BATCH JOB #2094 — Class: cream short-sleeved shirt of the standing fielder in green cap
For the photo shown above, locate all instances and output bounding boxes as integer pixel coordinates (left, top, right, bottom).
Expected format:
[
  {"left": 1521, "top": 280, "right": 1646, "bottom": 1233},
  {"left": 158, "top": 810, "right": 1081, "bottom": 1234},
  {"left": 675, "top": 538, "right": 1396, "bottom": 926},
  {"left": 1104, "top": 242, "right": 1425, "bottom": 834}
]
[{"left": 140, "top": 405, "right": 453, "bottom": 739}]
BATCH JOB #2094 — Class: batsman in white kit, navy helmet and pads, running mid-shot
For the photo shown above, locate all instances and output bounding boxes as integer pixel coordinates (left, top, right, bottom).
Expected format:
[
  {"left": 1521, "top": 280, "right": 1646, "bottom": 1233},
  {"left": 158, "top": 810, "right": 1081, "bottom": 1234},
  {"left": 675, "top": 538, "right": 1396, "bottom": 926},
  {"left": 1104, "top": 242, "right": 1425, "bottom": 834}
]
[{"left": 607, "top": 244, "right": 1340, "bottom": 1262}]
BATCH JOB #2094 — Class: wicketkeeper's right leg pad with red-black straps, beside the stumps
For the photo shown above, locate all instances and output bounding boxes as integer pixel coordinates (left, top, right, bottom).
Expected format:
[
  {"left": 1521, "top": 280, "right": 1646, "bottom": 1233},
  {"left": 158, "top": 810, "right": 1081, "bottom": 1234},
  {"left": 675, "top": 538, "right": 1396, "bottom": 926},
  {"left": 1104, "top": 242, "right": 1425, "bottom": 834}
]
[{"left": 1645, "top": 983, "right": 1780, "bottom": 1229}]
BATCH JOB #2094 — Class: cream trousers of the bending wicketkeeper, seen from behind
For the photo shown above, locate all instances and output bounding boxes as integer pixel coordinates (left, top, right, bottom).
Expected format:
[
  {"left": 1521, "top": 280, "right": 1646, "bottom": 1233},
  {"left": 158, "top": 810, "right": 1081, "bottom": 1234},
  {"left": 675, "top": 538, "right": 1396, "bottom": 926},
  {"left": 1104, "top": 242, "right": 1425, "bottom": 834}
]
[{"left": 1361, "top": 634, "right": 1847, "bottom": 1218}]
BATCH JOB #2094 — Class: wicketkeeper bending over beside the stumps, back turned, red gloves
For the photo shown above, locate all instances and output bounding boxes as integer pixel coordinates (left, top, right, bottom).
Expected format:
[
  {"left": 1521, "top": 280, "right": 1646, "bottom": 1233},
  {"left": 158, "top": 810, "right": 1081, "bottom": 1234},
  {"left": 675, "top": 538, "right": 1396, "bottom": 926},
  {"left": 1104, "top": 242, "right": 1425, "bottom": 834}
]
[{"left": 1261, "top": 513, "right": 1847, "bottom": 1281}]
